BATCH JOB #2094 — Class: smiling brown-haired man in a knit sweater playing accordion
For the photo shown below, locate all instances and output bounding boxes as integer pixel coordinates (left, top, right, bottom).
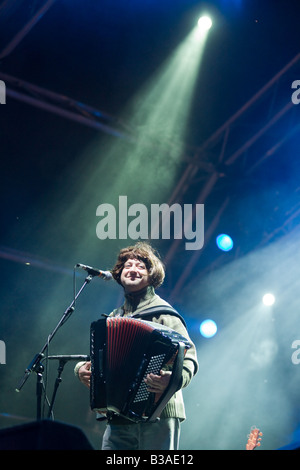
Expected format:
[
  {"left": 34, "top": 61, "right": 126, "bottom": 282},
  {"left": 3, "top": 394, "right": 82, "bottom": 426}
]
[{"left": 75, "top": 242, "right": 198, "bottom": 450}]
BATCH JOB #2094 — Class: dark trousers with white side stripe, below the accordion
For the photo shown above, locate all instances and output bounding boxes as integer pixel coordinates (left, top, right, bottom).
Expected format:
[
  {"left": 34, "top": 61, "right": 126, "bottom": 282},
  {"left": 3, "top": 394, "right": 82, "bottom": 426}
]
[{"left": 102, "top": 418, "right": 180, "bottom": 450}]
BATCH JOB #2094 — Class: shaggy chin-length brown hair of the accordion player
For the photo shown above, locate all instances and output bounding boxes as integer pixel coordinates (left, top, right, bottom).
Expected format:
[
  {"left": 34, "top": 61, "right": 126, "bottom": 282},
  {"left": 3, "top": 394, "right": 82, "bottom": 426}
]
[{"left": 111, "top": 242, "right": 165, "bottom": 288}]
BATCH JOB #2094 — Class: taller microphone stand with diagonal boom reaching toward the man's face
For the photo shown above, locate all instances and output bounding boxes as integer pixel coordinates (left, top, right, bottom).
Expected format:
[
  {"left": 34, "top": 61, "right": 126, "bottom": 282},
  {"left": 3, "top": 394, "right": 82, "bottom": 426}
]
[{"left": 16, "top": 274, "right": 94, "bottom": 421}]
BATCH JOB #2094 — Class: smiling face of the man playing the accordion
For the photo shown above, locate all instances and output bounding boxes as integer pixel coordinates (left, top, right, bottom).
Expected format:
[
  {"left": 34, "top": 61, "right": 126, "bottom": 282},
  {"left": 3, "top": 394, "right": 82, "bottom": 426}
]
[{"left": 121, "top": 259, "right": 149, "bottom": 292}]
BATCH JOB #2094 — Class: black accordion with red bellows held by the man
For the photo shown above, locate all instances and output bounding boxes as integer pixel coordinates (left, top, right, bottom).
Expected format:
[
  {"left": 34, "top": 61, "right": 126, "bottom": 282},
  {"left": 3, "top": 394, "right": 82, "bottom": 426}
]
[{"left": 90, "top": 317, "right": 190, "bottom": 422}]
